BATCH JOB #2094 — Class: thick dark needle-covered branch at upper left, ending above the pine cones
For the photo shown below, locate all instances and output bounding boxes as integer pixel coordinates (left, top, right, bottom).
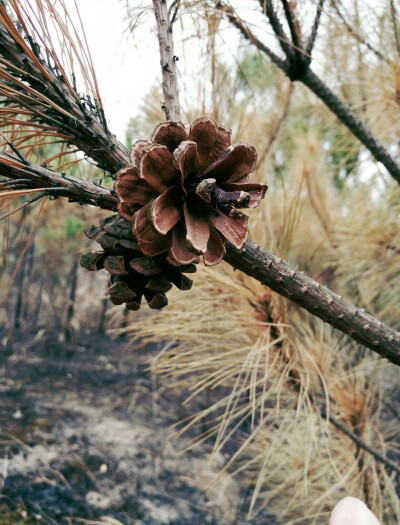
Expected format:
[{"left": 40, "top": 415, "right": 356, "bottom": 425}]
[{"left": 0, "top": 13, "right": 129, "bottom": 174}]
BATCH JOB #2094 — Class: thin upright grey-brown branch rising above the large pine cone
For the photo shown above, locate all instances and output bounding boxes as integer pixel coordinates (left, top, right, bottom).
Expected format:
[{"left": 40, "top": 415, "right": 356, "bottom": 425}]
[{"left": 153, "top": 0, "right": 181, "bottom": 120}]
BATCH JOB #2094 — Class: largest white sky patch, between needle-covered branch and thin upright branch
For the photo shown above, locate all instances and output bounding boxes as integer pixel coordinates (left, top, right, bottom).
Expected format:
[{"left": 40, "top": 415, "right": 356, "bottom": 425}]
[{"left": 71, "top": 0, "right": 161, "bottom": 141}]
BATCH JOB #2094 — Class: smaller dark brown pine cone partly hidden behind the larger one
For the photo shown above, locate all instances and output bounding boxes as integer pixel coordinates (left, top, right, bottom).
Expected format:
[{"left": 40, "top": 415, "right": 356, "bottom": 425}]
[{"left": 80, "top": 215, "right": 197, "bottom": 310}]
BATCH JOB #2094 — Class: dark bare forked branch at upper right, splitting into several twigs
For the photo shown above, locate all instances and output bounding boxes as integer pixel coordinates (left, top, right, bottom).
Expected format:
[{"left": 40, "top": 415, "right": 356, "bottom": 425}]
[{"left": 216, "top": 0, "right": 400, "bottom": 184}]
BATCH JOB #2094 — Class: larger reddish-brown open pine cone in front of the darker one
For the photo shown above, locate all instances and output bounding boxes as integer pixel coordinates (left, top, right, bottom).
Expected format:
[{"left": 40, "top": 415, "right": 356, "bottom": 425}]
[{"left": 114, "top": 117, "right": 267, "bottom": 267}]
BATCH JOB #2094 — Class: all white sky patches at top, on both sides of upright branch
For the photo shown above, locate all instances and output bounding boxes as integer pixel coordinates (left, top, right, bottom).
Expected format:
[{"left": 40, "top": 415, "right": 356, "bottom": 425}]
[{"left": 65, "top": 0, "right": 243, "bottom": 141}]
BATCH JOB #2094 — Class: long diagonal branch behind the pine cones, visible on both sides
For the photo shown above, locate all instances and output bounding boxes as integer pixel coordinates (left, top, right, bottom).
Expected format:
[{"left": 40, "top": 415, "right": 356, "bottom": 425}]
[{"left": 0, "top": 154, "right": 400, "bottom": 365}]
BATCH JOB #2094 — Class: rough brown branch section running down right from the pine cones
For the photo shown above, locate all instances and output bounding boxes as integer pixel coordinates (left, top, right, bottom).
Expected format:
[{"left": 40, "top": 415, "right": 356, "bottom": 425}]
[{"left": 225, "top": 241, "right": 400, "bottom": 366}]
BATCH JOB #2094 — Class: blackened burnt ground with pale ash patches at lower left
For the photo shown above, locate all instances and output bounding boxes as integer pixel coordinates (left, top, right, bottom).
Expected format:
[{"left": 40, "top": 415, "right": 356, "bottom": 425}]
[{"left": 0, "top": 331, "right": 273, "bottom": 525}]
